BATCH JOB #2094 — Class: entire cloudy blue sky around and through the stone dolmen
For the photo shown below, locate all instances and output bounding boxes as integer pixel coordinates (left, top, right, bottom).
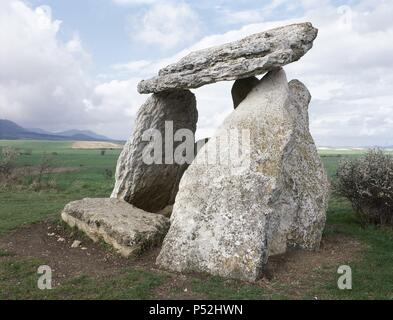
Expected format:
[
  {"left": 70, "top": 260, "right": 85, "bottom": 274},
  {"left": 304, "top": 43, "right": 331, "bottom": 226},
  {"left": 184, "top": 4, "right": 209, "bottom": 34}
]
[{"left": 0, "top": 0, "right": 393, "bottom": 146}]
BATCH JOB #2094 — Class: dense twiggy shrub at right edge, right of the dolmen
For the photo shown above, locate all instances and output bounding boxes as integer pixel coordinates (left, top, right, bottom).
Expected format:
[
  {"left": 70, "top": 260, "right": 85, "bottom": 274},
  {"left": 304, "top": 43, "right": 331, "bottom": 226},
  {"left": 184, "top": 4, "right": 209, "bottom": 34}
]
[{"left": 335, "top": 150, "right": 393, "bottom": 226}]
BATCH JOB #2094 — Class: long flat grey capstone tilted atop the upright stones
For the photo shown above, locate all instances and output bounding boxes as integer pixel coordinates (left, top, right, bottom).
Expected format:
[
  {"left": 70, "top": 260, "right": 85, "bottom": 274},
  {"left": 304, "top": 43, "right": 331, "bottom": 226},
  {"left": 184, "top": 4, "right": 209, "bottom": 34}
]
[{"left": 138, "top": 23, "right": 318, "bottom": 93}]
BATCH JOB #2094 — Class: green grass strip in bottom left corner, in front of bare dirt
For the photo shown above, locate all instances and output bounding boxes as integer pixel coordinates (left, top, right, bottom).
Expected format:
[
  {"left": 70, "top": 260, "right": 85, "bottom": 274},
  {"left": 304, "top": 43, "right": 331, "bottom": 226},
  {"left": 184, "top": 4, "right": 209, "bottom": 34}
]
[{"left": 0, "top": 259, "right": 166, "bottom": 300}]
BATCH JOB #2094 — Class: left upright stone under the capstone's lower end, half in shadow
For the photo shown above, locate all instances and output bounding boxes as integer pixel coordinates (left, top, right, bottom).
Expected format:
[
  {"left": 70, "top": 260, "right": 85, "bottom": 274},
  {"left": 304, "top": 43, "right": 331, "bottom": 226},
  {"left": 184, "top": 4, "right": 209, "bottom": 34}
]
[{"left": 111, "top": 90, "right": 198, "bottom": 212}]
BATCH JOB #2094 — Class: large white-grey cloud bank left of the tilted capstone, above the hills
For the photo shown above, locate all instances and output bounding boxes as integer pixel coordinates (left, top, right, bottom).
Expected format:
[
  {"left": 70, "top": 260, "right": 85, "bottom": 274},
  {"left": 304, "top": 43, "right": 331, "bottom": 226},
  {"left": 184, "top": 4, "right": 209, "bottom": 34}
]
[{"left": 0, "top": 0, "right": 140, "bottom": 138}]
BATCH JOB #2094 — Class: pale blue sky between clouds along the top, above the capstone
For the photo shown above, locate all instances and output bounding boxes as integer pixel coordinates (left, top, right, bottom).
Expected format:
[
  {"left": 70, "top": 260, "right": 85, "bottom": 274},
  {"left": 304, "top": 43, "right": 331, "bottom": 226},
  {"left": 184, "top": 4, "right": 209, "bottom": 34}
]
[{"left": 28, "top": 0, "right": 356, "bottom": 72}]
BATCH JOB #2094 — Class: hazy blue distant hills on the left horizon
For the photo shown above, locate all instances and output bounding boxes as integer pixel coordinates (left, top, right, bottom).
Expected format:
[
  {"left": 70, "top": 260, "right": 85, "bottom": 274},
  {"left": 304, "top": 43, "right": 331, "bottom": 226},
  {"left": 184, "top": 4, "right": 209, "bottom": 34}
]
[{"left": 0, "top": 119, "right": 113, "bottom": 141}]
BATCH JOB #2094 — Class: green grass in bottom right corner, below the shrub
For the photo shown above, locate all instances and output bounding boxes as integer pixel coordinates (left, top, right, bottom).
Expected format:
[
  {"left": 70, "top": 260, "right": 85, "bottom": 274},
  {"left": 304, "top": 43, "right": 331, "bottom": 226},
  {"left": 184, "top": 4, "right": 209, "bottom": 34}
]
[{"left": 316, "top": 199, "right": 393, "bottom": 299}]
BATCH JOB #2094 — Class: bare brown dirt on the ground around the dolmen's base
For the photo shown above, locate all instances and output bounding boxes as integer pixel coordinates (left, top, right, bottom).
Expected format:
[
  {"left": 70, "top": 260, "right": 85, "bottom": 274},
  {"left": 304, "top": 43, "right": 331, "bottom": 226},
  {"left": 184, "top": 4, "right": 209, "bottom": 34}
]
[{"left": 0, "top": 221, "right": 364, "bottom": 299}]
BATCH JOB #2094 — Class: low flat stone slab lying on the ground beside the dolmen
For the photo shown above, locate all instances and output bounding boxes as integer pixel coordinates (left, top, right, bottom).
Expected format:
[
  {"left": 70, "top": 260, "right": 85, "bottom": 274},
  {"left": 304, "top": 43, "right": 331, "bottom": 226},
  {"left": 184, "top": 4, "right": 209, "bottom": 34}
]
[{"left": 61, "top": 198, "right": 169, "bottom": 257}]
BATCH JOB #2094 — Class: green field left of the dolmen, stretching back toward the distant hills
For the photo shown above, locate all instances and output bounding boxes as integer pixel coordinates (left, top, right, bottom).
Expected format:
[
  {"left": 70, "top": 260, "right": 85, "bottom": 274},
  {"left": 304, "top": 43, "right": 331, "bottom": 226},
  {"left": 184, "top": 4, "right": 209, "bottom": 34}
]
[{"left": 0, "top": 140, "right": 120, "bottom": 235}]
